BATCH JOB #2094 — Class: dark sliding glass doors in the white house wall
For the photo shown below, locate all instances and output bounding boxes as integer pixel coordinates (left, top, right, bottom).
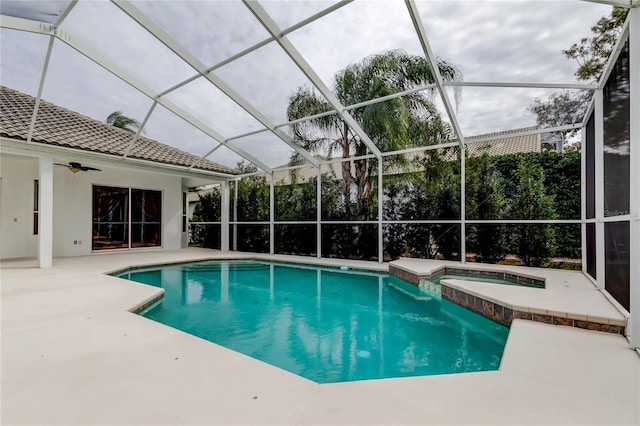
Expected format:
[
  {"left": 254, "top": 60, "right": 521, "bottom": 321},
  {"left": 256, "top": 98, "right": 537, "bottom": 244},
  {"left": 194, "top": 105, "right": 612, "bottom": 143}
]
[{"left": 91, "top": 185, "right": 162, "bottom": 250}]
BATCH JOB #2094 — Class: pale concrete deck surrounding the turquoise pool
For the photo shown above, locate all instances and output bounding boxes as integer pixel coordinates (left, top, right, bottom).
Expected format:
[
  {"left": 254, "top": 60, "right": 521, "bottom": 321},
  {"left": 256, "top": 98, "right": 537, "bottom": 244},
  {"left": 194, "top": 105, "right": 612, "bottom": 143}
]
[{"left": 0, "top": 249, "right": 640, "bottom": 425}]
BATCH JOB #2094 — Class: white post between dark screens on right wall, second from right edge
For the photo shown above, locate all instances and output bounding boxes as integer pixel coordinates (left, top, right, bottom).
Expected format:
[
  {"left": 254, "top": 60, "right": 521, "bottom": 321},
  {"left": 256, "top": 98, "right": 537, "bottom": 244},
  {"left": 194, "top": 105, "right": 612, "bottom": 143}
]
[{"left": 593, "top": 89, "right": 606, "bottom": 288}]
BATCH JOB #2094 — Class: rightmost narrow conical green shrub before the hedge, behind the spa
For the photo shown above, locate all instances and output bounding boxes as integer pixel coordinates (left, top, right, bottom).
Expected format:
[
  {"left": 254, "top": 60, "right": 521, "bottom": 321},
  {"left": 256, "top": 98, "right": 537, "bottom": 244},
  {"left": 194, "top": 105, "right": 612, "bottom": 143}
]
[{"left": 512, "top": 158, "right": 555, "bottom": 266}]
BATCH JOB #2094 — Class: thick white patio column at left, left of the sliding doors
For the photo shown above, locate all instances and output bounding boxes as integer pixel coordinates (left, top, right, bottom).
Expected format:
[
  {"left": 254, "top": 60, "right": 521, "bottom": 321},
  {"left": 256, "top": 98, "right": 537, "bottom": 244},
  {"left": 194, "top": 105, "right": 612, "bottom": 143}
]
[{"left": 38, "top": 157, "right": 53, "bottom": 268}]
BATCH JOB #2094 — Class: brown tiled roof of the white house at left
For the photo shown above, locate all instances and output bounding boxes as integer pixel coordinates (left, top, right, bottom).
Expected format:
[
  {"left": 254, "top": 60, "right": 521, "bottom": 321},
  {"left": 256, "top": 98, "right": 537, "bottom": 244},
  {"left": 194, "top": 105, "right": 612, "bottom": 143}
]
[{"left": 0, "top": 86, "right": 239, "bottom": 174}]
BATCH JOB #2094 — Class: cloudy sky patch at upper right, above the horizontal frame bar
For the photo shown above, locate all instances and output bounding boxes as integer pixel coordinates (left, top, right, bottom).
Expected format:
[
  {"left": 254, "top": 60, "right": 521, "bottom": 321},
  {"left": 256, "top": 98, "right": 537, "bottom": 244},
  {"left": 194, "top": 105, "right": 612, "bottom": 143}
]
[{"left": 419, "top": 1, "right": 611, "bottom": 83}]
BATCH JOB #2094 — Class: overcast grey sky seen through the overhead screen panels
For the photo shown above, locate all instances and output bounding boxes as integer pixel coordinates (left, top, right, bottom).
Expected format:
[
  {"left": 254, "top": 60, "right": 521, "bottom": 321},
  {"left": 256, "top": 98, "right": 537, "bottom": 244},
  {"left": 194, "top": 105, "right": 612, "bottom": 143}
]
[{"left": 0, "top": 0, "right": 611, "bottom": 167}]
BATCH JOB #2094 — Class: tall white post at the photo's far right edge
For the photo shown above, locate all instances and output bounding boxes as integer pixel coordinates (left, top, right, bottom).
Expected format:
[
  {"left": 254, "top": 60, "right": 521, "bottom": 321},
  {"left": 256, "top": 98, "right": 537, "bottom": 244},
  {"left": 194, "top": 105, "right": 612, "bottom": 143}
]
[{"left": 628, "top": 7, "right": 640, "bottom": 349}]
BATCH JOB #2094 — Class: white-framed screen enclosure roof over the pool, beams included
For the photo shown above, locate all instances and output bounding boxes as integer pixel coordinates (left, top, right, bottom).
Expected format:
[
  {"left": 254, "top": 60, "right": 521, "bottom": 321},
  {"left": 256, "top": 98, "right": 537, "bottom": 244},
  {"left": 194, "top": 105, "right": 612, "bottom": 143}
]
[{"left": 0, "top": 0, "right": 633, "bottom": 177}]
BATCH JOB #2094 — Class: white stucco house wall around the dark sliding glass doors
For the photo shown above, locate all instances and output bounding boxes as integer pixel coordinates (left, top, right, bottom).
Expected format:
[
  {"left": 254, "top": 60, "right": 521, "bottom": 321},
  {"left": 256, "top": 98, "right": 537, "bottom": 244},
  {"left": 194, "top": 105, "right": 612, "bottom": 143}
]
[{"left": 0, "top": 155, "right": 182, "bottom": 259}]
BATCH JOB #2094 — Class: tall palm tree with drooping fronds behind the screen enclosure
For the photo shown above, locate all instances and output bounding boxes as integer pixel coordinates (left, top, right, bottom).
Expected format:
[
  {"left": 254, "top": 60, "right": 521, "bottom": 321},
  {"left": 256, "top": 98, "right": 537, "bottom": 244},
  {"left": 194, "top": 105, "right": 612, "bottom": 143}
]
[{"left": 287, "top": 50, "right": 462, "bottom": 219}]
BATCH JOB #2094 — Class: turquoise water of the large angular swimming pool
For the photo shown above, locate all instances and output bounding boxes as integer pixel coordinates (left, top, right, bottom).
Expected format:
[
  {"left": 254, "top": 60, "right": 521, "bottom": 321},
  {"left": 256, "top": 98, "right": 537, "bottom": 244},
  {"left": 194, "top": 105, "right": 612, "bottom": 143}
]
[{"left": 118, "top": 261, "right": 508, "bottom": 383}]
